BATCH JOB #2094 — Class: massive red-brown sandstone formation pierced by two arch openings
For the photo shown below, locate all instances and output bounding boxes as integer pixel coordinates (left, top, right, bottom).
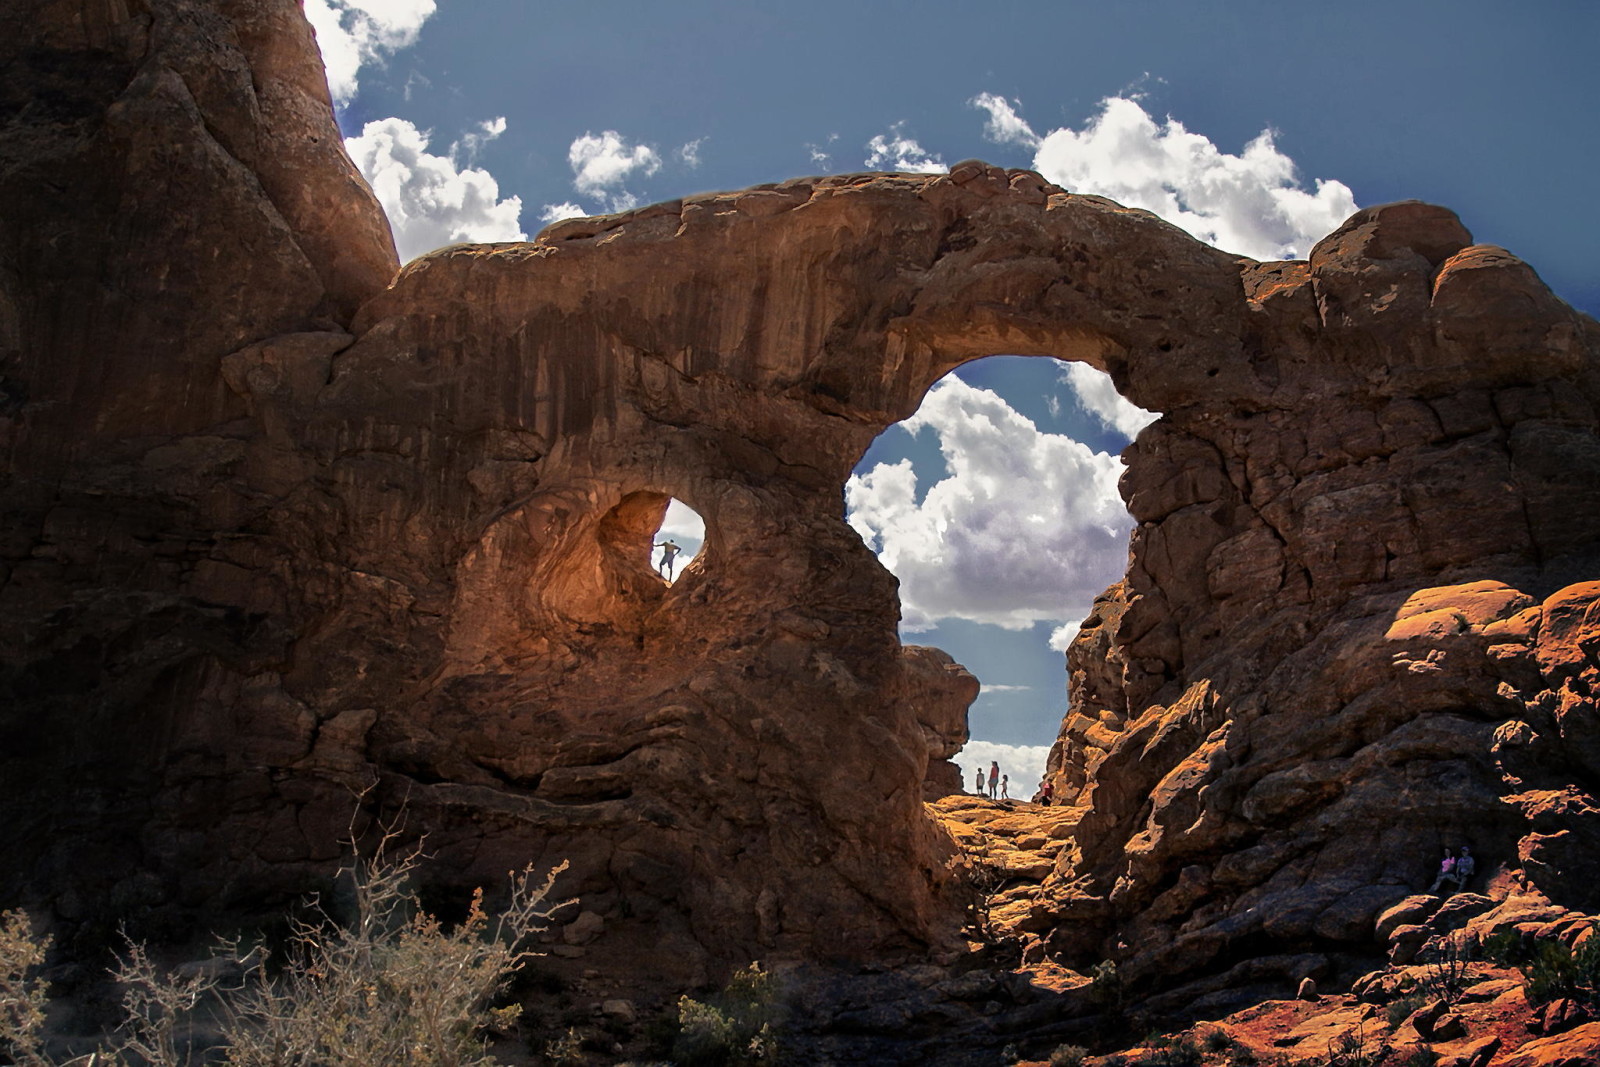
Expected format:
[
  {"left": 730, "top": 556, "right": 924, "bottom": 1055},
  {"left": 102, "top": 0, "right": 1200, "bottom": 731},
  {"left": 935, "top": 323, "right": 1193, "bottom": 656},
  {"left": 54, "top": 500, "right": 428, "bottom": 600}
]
[{"left": 0, "top": 0, "right": 1600, "bottom": 1004}]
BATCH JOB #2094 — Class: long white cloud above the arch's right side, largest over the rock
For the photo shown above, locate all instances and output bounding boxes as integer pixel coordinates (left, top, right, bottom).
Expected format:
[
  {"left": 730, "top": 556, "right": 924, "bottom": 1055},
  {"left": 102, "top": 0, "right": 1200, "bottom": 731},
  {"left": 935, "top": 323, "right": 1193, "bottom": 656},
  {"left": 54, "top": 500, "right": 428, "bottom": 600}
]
[{"left": 973, "top": 93, "right": 1357, "bottom": 259}]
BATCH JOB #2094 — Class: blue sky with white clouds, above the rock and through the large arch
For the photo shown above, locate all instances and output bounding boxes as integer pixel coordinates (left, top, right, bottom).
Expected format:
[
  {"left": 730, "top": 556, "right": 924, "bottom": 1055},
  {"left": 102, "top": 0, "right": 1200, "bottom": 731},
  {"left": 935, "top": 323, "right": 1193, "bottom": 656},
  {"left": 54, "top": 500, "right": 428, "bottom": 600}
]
[{"left": 306, "top": 0, "right": 1600, "bottom": 792}]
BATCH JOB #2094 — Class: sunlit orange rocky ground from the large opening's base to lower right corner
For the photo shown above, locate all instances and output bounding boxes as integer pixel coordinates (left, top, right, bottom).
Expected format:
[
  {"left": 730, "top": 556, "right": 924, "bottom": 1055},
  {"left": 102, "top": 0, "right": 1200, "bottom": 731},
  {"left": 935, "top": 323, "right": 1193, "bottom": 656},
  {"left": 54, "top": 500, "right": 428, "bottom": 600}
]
[{"left": 930, "top": 795, "right": 1600, "bottom": 1067}]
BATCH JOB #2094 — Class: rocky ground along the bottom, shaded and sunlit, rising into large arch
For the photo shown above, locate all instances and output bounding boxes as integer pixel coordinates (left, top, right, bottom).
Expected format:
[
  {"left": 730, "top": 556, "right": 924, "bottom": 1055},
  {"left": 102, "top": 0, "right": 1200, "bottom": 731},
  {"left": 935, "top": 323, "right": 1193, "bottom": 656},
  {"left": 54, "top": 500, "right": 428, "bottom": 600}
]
[{"left": 21, "top": 795, "right": 1600, "bottom": 1067}]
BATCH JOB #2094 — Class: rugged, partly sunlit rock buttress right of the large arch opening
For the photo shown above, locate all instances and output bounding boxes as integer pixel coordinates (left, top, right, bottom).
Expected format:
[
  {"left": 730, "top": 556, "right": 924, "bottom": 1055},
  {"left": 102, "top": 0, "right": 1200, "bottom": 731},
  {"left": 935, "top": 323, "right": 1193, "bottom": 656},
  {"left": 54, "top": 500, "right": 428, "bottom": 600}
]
[{"left": 1040, "top": 203, "right": 1600, "bottom": 1004}]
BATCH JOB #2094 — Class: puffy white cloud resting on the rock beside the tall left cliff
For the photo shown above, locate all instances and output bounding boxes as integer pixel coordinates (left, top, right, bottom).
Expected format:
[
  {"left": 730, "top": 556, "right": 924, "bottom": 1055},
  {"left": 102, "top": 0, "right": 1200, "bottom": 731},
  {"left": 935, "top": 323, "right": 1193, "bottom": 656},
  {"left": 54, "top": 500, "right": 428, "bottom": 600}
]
[{"left": 344, "top": 118, "right": 528, "bottom": 262}]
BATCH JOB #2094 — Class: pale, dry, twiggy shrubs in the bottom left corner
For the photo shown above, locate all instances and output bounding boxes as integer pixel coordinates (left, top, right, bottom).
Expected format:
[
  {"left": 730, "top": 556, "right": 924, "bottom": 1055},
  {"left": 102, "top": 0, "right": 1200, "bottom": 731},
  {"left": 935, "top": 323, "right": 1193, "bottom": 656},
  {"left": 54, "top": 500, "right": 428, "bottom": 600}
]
[{"left": 0, "top": 838, "right": 565, "bottom": 1067}]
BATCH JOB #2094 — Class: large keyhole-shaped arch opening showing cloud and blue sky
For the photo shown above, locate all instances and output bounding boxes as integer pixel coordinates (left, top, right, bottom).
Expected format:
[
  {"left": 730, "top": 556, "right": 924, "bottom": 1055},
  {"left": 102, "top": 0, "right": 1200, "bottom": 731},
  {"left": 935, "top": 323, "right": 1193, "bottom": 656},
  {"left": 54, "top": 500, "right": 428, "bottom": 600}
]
[{"left": 845, "top": 355, "right": 1157, "bottom": 800}]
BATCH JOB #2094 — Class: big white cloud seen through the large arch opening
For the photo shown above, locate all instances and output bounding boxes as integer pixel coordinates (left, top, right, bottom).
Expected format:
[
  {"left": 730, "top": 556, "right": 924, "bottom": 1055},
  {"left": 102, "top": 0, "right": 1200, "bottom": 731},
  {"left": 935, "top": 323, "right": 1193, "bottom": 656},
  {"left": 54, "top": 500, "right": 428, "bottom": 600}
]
[{"left": 845, "top": 374, "right": 1133, "bottom": 632}]
